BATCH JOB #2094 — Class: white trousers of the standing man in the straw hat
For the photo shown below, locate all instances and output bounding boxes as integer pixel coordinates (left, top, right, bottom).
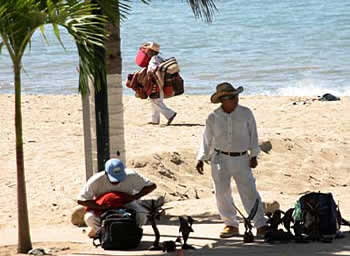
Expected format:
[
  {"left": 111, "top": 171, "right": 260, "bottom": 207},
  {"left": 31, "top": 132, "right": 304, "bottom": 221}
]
[{"left": 211, "top": 152, "right": 266, "bottom": 228}]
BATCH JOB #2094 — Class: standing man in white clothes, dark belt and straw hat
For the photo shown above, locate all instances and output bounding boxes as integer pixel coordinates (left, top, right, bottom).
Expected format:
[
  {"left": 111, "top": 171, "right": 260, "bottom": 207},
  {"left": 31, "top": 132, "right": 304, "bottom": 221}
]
[{"left": 196, "top": 82, "right": 266, "bottom": 238}]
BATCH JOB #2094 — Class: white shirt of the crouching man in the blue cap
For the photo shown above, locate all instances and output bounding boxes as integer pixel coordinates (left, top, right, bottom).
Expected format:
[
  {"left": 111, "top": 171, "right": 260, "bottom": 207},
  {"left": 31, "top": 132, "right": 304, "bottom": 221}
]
[{"left": 78, "top": 169, "right": 153, "bottom": 201}]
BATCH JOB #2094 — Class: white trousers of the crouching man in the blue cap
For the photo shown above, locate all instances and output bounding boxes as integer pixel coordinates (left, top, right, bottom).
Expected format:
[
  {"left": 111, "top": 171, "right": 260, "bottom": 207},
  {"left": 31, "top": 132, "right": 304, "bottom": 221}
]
[{"left": 84, "top": 201, "right": 147, "bottom": 231}]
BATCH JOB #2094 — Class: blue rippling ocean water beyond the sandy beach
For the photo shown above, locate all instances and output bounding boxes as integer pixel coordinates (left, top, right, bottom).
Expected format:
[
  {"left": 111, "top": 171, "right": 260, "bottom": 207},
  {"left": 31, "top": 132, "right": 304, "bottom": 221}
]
[{"left": 0, "top": 0, "right": 350, "bottom": 96}]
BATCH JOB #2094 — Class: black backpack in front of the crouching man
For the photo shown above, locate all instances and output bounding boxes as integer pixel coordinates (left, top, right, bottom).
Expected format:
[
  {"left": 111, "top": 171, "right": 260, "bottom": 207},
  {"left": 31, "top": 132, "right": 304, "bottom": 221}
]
[{"left": 93, "top": 209, "right": 143, "bottom": 250}]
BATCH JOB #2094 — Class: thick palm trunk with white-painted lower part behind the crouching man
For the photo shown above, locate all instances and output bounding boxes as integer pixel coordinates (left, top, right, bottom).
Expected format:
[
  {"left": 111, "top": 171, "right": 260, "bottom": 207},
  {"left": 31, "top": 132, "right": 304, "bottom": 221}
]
[{"left": 105, "top": 11, "right": 126, "bottom": 162}]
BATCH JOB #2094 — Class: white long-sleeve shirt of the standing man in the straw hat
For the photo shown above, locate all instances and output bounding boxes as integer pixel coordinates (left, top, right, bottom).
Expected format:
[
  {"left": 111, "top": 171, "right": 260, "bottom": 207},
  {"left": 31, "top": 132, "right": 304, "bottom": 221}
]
[{"left": 197, "top": 105, "right": 260, "bottom": 161}]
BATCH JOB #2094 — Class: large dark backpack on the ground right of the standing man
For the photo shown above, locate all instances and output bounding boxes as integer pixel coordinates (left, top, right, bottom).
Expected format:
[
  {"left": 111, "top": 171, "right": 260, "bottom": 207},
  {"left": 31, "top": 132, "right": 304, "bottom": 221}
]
[{"left": 294, "top": 192, "right": 340, "bottom": 240}]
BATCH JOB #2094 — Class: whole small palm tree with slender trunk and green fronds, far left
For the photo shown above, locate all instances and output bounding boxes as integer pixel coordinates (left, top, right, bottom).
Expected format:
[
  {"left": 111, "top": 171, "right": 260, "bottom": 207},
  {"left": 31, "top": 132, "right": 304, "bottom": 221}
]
[{"left": 0, "top": 0, "right": 106, "bottom": 253}]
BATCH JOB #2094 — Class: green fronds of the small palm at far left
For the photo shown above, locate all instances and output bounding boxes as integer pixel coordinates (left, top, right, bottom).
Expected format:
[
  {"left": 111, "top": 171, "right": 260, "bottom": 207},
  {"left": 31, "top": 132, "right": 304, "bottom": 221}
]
[{"left": 0, "top": 0, "right": 107, "bottom": 92}]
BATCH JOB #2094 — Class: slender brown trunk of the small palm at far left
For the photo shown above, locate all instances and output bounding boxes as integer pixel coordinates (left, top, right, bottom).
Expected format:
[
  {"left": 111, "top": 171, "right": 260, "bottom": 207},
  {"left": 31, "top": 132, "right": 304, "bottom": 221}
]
[{"left": 14, "top": 60, "right": 32, "bottom": 253}]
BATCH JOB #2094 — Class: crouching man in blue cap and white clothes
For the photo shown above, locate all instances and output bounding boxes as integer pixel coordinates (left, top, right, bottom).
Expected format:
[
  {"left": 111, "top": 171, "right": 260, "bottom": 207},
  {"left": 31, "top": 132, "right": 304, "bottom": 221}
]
[{"left": 78, "top": 159, "right": 157, "bottom": 238}]
